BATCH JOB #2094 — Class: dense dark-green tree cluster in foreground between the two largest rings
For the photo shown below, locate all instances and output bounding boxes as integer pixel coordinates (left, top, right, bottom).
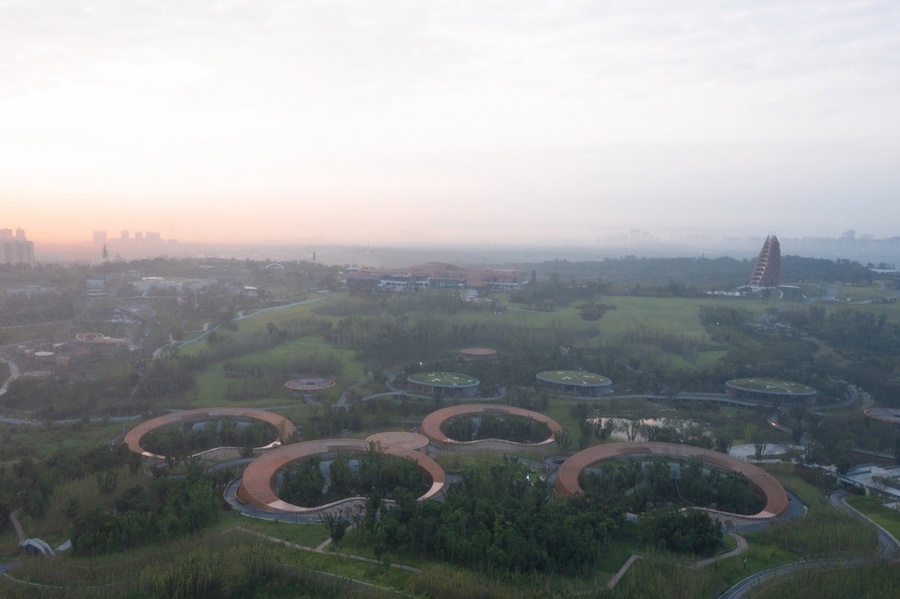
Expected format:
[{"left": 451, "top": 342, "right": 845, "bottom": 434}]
[{"left": 355, "top": 460, "right": 623, "bottom": 574}]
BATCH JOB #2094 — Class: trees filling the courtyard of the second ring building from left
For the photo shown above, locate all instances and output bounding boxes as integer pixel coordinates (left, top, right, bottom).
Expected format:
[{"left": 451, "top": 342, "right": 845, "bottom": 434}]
[{"left": 278, "top": 448, "right": 425, "bottom": 507}]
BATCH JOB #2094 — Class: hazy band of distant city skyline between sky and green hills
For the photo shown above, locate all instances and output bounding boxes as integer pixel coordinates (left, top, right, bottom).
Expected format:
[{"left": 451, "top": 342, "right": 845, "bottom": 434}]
[{"left": 26, "top": 229, "right": 900, "bottom": 268}]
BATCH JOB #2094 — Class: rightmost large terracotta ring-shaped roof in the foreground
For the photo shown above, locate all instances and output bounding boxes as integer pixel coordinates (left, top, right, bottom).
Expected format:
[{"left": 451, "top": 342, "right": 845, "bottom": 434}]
[{"left": 553, "top": 443, "right": 788, "bottom": 520}]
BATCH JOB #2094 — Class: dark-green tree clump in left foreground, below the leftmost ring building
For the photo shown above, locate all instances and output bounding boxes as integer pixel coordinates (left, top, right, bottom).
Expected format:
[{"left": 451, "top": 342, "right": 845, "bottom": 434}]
[{"left": 70, "top": 468, "right": 222, "bottom": 556}]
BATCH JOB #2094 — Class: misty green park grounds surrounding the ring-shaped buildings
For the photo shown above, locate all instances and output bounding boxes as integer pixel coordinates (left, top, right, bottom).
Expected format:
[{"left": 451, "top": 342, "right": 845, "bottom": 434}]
[{"left": 0, "top": 257, "right": 900, "bottom": 598}]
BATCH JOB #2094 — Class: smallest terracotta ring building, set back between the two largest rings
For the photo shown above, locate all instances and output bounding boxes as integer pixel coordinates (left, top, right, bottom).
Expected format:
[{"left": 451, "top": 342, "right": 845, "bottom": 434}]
[{"left": 419, "top": 404, "right": 563, "bottom": 451}]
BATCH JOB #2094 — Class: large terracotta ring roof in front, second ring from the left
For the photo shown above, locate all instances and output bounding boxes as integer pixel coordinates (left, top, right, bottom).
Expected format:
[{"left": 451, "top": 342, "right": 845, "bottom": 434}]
[{"left": 237, "top": 439, "right": 447, "bottom": 514}]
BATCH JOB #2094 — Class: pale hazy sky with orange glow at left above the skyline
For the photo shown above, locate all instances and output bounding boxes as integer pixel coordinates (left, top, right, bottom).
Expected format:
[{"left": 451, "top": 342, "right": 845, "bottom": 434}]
[{"left": 0, "top": 0, "right": 900, "bottom": 244}]
